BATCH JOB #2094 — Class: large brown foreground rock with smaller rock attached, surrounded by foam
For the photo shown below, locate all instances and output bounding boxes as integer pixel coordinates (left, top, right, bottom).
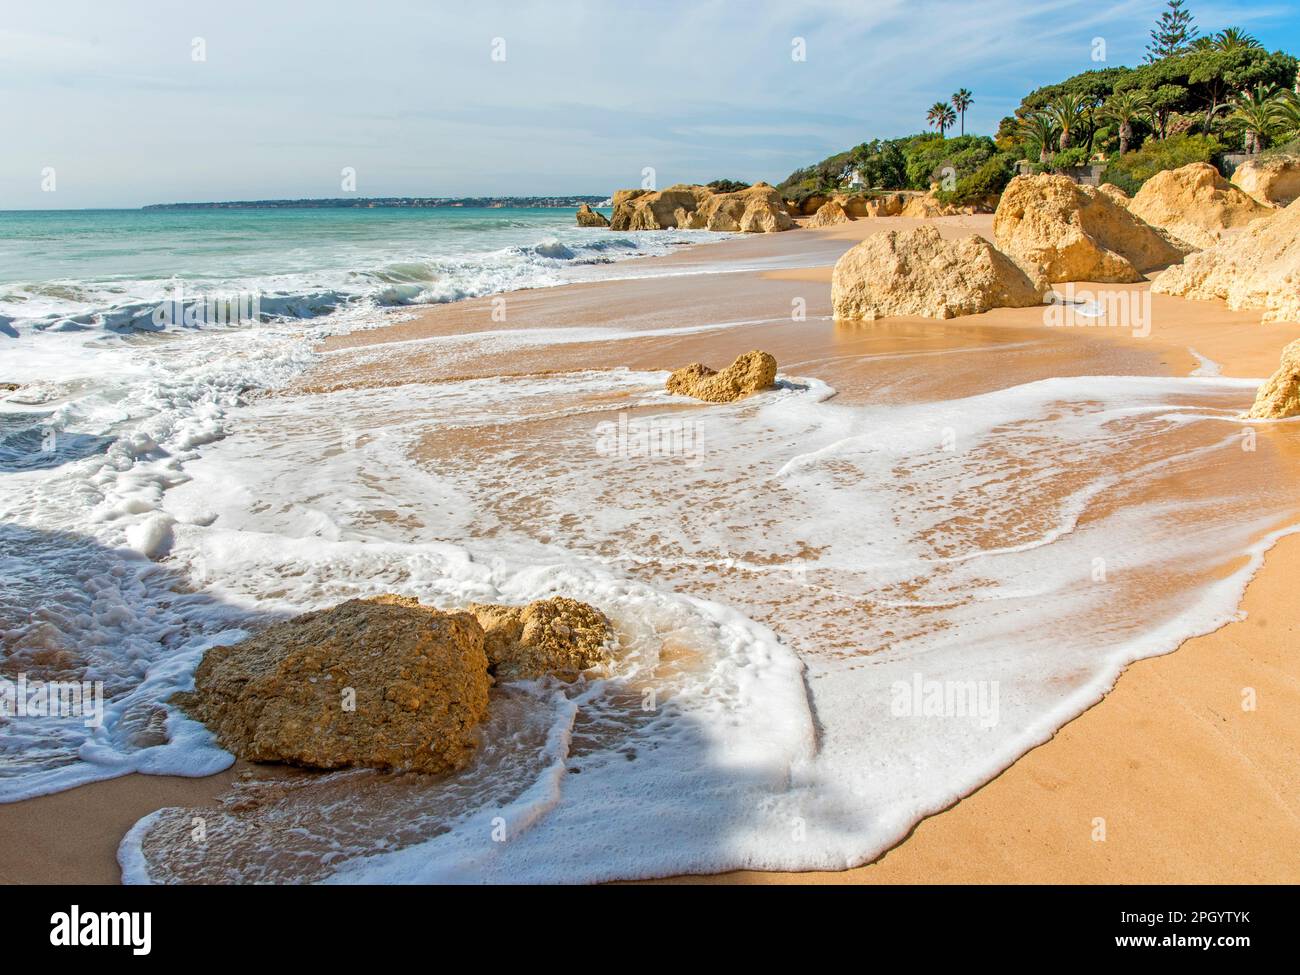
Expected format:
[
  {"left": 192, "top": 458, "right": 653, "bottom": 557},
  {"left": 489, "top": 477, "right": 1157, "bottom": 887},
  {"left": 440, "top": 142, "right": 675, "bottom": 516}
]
[{"left": 173, "top": 595, "right": 612, "bottom": 772}]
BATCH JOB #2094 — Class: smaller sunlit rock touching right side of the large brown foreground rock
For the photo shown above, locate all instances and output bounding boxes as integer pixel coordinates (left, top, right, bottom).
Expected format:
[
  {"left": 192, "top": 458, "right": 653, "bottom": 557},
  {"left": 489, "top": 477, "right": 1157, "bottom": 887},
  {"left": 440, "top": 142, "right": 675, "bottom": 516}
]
[{"left": 469, "top": 597, "right": 612, "bottom": 681}]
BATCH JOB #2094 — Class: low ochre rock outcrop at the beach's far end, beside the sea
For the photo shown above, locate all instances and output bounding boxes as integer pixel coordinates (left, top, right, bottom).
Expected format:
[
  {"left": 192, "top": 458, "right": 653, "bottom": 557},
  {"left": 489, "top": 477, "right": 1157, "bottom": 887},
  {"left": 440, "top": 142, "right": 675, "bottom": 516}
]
[{"left": 610, "top": 182, "right": 794, "bottom": 234}]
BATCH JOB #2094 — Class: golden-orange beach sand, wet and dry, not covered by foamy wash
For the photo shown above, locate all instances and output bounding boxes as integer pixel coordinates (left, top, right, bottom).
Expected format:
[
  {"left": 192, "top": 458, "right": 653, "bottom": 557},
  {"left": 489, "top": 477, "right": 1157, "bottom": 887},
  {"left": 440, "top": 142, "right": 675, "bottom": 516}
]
[{"left": 0, "top": 216, "right": 1300, "bottom": 884}]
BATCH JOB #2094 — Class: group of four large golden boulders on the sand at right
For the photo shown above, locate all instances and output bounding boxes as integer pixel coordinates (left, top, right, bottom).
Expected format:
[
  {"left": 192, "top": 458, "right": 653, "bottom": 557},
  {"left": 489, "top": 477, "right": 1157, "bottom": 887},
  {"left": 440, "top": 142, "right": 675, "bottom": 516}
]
[{"left": 832, "top": 163, "right": 1300, "bottom": 321}]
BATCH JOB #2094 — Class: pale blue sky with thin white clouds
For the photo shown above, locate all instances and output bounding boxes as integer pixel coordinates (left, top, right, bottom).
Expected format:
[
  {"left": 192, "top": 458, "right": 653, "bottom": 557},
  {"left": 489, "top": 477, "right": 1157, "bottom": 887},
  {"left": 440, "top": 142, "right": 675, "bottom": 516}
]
[{"left": 0, "top": 0, "right": 1300, "bottom": 209}]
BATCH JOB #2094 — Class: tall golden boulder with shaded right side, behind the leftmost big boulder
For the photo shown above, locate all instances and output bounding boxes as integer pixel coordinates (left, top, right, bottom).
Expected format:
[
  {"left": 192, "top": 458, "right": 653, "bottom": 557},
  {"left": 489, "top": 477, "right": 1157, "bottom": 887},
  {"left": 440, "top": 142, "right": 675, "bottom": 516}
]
[{"left": 993, "top": 174, "right": 1191, "bottom": 283}]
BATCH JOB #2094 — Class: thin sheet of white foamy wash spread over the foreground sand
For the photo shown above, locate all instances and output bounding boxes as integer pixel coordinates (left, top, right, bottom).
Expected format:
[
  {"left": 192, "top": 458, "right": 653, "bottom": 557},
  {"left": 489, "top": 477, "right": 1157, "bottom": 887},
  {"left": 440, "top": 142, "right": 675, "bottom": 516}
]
[{"left": 116, "top": 328, "right": 1294, "bottom": 881}]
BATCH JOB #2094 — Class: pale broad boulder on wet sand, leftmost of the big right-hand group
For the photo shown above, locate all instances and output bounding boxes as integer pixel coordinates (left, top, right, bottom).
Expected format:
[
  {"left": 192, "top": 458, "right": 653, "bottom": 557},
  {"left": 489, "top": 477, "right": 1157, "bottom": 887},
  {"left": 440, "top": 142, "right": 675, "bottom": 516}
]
[{"left": 831, "top": 226, "right": 1045, "bottom": 320}]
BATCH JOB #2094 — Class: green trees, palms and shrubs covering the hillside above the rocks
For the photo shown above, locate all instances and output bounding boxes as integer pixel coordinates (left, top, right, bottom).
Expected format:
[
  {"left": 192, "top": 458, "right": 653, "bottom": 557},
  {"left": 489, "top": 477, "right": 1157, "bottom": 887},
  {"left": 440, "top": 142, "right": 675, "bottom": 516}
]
[{"left": 777, "top": 0, "right": 1300, "bottom": 204}]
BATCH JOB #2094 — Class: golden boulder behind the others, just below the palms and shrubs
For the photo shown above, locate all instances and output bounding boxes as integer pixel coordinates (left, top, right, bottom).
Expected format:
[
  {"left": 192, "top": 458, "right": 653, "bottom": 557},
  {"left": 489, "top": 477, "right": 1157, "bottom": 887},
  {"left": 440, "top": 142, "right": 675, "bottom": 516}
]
[{"left": 1128, "top": 163, "right": 1273, "bottom": 247}]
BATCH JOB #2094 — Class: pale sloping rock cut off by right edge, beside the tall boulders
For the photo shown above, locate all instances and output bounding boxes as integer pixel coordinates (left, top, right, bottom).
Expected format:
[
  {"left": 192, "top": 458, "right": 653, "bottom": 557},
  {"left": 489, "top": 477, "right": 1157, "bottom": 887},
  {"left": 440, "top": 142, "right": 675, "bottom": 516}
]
[{"left": 1151, "top": 200, "right": 1300, "bottom": 321}]
